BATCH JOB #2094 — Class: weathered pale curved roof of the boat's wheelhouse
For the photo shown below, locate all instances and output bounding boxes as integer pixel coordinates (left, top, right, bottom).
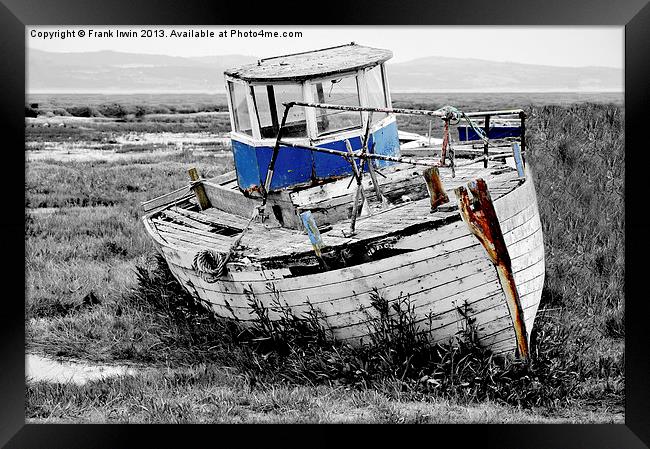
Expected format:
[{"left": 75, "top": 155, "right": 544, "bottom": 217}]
[{"left": 224, "top": 42, "right": 393, "bottom": 82}]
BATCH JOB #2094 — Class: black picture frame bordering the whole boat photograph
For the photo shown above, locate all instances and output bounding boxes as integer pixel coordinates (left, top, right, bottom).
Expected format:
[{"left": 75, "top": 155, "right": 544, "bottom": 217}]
[{"left": 5, "top": 0, "right": 650, "bottom": 449}]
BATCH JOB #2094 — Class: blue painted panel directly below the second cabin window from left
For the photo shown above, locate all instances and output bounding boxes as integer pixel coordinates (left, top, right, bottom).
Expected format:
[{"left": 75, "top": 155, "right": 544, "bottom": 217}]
[{"left": 256, "top": 146, "right": 314, "bottom": 190}]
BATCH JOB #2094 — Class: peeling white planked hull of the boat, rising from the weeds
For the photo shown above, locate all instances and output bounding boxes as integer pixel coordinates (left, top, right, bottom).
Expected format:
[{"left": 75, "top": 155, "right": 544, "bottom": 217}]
[{"left": 145, "top": 166, "right": 544, "bottom": 354}]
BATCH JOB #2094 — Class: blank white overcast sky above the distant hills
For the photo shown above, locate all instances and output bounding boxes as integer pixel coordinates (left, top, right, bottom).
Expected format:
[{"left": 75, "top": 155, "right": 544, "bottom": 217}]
[{"left": 26, "top": 25, "right": 624, "bottom": 68}]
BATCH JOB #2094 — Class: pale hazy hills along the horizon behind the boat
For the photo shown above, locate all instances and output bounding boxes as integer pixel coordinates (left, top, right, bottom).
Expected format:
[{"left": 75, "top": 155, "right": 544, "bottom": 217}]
[{"left": 26, "top": 49, "right": 623, "bottom": 93}]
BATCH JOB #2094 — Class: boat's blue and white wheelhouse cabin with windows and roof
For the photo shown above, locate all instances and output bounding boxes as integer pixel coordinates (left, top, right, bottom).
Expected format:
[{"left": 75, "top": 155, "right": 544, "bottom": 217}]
[{"left": 224, "top": 43, "right": 400, "bottom": 196}]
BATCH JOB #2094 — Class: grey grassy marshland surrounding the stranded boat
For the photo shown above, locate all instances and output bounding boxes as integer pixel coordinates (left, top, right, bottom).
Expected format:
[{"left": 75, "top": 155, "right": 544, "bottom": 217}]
[{"left": 25, "top": 94, "right": 625, "bottom": 422}]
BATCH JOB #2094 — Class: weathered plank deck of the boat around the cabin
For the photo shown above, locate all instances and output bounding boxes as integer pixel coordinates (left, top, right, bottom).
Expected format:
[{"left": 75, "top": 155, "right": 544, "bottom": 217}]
[{"left": 145, "top": 161, "right": 521, "bottom": 270}]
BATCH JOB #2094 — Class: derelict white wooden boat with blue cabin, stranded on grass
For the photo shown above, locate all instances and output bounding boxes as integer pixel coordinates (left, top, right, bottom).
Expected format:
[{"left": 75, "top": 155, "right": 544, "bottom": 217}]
[{"left": 143, "top": 44, "right": 544, "bottom": 358}]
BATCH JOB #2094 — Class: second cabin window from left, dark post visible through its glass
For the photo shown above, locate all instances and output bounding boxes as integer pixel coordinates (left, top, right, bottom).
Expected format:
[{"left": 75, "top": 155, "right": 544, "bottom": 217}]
[{"left": 253, "top": 84, "right": 307, "bottom": 139}]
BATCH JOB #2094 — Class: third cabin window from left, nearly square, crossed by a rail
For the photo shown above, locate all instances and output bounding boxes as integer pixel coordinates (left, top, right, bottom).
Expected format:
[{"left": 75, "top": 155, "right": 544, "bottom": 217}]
[{"left": 311, "top": 76, "right": 362, "bottom": 136}]
